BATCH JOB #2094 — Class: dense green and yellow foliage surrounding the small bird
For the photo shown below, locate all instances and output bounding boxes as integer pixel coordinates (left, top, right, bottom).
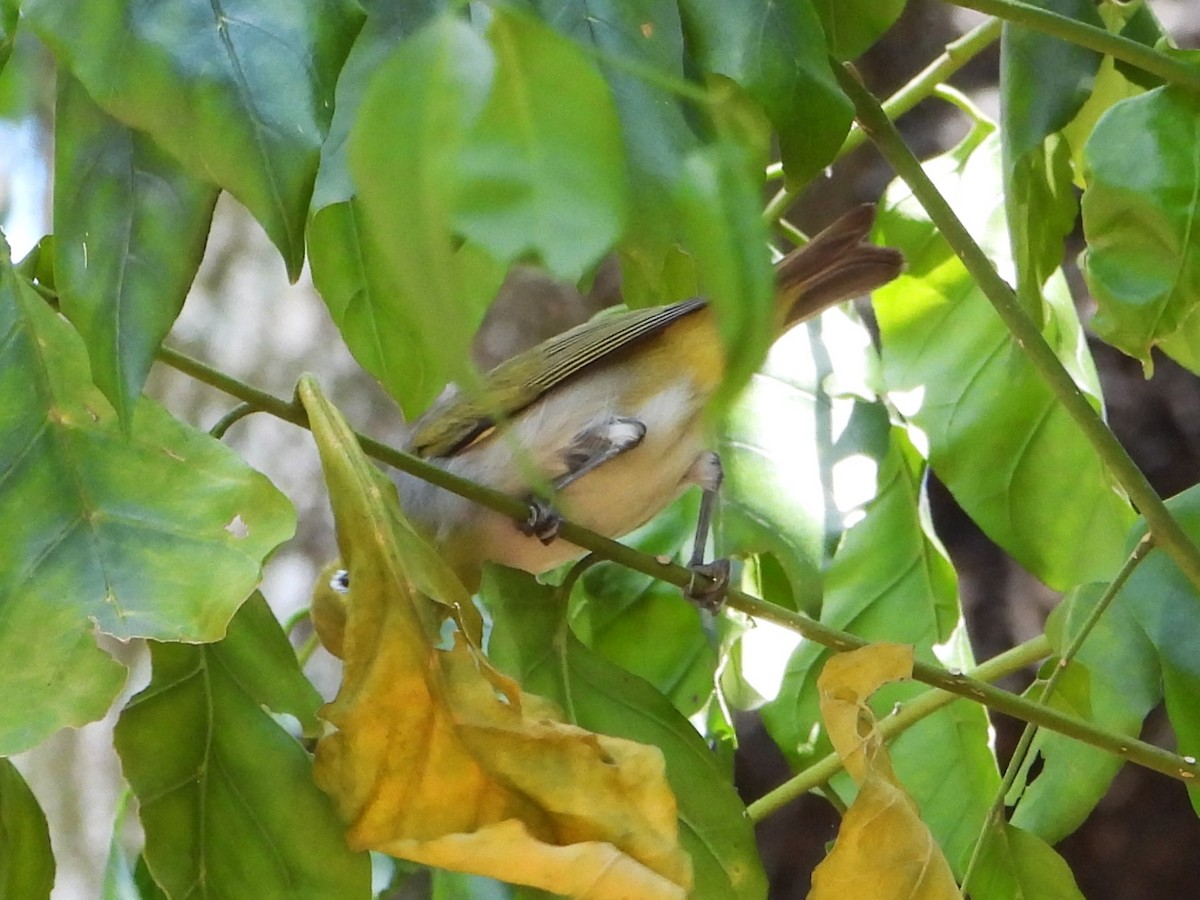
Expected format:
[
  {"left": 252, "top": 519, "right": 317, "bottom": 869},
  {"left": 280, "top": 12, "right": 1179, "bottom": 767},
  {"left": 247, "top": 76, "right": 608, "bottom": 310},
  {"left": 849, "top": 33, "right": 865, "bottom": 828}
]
[{"left": 0, "top": 0, "right": 1200, "bottom": 899}]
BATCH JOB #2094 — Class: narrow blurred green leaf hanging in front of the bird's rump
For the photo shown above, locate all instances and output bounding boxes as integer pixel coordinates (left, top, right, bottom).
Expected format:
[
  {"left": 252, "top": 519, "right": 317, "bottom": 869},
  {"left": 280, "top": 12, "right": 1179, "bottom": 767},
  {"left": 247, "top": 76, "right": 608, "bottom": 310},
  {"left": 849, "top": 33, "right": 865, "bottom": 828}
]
[{"left": 678, "top": 138, "right": 775, "bottom": 410}]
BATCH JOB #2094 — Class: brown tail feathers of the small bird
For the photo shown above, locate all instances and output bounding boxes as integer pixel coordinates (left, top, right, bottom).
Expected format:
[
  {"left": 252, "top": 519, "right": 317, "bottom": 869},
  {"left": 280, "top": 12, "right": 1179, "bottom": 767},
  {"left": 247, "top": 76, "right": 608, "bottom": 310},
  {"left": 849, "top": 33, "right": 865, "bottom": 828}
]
[{"left": 775, "top": 205, "right": 904, "bottom": 329}]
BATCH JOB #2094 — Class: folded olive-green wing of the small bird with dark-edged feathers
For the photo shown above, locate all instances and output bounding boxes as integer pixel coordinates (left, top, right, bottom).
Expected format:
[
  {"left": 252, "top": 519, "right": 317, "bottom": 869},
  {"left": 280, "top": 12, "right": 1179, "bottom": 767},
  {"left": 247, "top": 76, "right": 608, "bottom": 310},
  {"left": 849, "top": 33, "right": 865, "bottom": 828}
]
[{"left": 408, "top": 298, "right": 706, "bottom": 457}]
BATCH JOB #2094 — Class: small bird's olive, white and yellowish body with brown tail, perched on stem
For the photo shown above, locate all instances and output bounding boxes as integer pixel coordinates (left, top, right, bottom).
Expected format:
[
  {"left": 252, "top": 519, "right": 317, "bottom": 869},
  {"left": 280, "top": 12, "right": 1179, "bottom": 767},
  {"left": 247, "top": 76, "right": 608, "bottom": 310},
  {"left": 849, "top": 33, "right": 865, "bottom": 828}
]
[{"left": 397, "top": 206, "right": 904, "bottom": 606}]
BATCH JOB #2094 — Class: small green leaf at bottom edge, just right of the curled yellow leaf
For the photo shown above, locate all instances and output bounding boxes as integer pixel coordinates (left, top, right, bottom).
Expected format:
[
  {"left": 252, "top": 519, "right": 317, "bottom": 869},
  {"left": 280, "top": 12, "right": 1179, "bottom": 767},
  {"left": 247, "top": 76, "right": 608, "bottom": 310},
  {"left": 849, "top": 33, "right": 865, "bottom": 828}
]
[{"left": 971, "top": 824, "right": 1084, "bottom": 900}]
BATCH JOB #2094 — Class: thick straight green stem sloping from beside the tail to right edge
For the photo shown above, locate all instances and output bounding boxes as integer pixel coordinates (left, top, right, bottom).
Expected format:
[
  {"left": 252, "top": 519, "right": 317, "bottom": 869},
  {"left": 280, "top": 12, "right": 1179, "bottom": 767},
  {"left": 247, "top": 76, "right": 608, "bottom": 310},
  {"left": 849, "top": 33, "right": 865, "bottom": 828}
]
[{"left": 836, "top": 66, "right": 1200, "bottom": 600}]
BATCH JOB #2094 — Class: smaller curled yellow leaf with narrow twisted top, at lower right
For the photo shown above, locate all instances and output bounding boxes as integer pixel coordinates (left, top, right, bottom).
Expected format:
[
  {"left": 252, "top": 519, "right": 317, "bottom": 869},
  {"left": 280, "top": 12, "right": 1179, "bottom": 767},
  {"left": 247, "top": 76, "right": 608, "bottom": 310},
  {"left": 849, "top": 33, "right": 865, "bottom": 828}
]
[{"left": 809, "top": 644, "right": 961, "bottom": 900}]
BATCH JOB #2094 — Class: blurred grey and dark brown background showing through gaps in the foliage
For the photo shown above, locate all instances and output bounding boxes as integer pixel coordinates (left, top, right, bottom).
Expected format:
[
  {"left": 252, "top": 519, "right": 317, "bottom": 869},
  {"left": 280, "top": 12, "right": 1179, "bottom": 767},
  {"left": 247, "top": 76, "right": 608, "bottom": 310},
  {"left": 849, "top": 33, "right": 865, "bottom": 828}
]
[{"left": 0, "top": 0, "right": 1200, "bottom": 900}]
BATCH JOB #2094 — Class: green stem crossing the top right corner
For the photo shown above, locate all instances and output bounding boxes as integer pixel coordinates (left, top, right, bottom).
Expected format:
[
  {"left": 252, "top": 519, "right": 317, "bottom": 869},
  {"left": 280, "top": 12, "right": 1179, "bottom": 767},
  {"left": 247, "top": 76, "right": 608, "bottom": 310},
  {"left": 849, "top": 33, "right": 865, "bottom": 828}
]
[{"left": 948, "top": 0, "right": 1200, "bottom": 91}]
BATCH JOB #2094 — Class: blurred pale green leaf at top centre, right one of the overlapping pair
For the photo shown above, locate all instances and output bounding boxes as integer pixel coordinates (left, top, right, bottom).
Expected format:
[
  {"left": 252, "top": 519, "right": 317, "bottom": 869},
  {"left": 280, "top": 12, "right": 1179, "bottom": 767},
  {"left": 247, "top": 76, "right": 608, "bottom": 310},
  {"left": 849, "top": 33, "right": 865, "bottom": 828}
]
[{"left": 454, "top": 8, "right": 629, "bottom": 281}]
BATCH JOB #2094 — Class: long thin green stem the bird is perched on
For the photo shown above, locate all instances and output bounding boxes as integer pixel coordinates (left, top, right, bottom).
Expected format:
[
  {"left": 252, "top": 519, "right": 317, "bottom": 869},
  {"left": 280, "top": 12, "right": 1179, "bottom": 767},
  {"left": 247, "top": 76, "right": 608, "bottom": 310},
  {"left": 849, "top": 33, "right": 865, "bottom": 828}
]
[{"left": 158, "top": 348, "right": 1200, "bottom": 779}]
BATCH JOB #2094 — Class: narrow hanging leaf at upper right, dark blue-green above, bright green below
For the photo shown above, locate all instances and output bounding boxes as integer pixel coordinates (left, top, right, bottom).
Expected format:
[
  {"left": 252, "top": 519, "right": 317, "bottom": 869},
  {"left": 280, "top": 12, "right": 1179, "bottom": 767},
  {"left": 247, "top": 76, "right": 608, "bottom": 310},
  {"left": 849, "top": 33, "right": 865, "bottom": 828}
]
[{"left": 1000, "top": 0, "right": 1104, "bottom": 307}]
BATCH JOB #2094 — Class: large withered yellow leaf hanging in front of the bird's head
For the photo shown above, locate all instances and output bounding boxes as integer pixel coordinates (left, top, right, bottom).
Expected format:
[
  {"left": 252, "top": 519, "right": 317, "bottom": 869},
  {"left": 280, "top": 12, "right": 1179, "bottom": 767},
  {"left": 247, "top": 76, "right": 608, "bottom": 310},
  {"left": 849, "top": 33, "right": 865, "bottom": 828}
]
[{"left": 299, "top": 378, "right": 691, "bottom": 899}]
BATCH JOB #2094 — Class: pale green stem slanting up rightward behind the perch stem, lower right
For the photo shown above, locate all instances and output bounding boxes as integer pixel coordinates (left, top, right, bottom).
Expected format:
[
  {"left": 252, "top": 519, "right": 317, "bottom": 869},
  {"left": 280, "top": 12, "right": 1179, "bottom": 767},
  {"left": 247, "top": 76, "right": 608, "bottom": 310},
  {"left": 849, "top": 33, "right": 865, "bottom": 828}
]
[{"left": 746, "top": 635, "right": 1050, "bottom": 822}]
